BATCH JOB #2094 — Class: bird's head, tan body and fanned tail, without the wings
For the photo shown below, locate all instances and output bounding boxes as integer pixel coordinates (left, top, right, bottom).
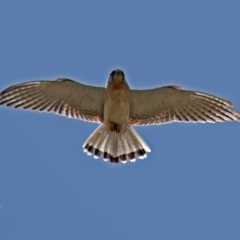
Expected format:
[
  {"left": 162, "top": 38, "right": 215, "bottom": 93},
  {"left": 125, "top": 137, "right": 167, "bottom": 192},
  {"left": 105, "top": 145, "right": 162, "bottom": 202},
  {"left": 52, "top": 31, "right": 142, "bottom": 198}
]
[{"left": 83, "top": 70, "right": 150, "bottom": 163}]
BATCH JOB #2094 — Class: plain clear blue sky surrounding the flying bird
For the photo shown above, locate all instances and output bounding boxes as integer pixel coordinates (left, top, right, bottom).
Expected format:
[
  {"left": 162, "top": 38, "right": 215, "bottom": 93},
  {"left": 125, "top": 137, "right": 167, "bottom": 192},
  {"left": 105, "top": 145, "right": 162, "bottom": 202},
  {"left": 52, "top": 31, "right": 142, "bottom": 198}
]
[{"left": 0, "top": 0, "right": 240, "bottom": 240}]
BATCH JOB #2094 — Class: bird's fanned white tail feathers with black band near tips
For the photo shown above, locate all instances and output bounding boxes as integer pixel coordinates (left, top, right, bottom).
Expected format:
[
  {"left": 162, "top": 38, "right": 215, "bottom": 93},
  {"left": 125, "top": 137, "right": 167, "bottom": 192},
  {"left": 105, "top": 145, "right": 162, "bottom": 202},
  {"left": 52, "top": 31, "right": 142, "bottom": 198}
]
[{"left": 83, "top": 124, "right": 151, "bottom": 163}]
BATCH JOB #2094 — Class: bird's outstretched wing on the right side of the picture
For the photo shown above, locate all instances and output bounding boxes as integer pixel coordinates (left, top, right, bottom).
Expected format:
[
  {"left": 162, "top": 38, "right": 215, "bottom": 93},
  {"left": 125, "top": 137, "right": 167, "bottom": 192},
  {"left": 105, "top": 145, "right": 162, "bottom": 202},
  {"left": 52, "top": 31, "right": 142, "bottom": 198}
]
[{"left": 129, "top": 86, "right": 240, "bottom": 125}]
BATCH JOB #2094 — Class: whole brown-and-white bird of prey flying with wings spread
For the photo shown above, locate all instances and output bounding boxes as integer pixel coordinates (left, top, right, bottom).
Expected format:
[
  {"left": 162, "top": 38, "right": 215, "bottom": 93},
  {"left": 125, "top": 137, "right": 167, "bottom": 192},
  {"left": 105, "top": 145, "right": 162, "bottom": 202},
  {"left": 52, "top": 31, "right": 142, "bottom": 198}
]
[{"left": 0, "top": 69, "right": 240, "bottom": 163}]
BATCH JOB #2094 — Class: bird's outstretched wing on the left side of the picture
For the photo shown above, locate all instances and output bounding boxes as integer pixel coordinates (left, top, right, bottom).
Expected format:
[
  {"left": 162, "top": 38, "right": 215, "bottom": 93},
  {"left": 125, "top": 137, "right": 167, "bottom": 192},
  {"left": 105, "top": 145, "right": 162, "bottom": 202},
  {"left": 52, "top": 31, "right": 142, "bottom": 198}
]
[{"left": 0, "top": 78, "right": 104, "bottom": 122}]
